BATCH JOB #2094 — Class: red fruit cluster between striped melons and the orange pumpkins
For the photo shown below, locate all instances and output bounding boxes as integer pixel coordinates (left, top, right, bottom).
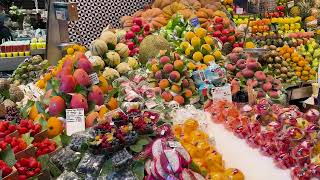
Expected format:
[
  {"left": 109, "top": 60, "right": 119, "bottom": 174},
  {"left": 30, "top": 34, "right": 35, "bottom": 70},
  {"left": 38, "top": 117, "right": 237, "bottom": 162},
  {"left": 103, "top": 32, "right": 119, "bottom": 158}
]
[{"left": 125, "top": 17, "right": 150, "bottom": 56}]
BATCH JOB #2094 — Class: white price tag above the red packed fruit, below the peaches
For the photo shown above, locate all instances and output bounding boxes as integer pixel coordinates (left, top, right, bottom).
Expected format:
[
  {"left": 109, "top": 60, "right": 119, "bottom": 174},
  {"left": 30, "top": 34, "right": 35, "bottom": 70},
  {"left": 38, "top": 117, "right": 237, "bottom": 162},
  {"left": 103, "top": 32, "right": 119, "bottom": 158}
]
[{"left": 211, "top": 84, "right": 232, "bottom": 102}]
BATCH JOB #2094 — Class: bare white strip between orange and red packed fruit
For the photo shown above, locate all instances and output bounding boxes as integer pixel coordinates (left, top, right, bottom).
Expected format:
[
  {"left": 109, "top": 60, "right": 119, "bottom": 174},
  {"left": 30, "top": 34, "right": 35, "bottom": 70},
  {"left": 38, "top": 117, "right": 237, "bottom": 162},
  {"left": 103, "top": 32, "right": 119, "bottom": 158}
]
[{"left": 208, "top": 122, "right": 291, "bottom": 180}]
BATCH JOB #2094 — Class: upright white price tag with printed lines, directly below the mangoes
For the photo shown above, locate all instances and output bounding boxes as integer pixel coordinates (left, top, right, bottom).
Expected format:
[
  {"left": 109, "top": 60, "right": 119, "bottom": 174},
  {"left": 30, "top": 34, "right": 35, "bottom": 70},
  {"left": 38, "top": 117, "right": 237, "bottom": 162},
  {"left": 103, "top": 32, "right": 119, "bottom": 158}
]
[{"left": 66, "top": 109, "right": 86, "bottom": 136}]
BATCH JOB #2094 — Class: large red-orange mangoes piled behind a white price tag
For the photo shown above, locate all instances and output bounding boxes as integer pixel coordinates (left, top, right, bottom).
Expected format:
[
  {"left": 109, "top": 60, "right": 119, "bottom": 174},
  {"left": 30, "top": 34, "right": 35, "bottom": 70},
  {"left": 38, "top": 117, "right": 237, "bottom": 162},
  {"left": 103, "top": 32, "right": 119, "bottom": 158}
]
[{"left": 48, "top": 54, "right": 104, "bottom": 116}]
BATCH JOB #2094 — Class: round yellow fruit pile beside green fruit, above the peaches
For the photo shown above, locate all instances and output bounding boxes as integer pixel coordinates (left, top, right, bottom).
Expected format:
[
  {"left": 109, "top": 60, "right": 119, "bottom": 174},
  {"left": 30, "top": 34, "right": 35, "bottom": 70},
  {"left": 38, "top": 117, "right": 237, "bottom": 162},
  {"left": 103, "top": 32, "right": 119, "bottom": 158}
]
[{"left": 179, "top": 28, "right": 222, "bottom": 70}]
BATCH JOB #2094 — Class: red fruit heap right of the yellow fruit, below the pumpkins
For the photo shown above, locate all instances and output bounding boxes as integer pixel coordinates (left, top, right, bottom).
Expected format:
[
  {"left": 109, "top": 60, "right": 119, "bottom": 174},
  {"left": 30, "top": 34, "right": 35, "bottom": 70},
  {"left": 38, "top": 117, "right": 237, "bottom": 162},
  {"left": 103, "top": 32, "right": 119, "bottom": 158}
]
[{"left": 209, "top": 17, "right": 236, "bottom": 44}]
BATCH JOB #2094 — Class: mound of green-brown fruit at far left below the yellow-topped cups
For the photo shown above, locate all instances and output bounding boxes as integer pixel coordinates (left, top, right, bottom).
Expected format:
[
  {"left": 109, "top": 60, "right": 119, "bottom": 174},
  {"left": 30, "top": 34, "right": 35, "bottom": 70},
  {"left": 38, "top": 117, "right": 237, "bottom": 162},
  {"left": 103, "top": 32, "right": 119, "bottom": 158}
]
[{"left": 10, "top": 56, "right": 50, "bottom": 85}]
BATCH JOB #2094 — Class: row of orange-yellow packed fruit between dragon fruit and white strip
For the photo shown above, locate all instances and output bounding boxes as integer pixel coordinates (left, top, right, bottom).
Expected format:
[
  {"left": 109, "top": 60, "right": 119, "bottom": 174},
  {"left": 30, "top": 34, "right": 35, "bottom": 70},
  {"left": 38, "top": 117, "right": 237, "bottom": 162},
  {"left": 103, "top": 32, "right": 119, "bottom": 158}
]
[{"left": 173, "top": 119, "right": 244, "bottom": 180}]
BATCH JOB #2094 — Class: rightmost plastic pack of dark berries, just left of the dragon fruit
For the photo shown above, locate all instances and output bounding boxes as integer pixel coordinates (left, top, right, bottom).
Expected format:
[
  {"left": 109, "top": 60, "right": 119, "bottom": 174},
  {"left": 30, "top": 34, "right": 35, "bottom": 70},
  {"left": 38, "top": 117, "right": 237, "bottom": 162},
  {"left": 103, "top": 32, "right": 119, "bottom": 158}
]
[{"left": 111, "top": 149, "right": 133, "bottom": 169}]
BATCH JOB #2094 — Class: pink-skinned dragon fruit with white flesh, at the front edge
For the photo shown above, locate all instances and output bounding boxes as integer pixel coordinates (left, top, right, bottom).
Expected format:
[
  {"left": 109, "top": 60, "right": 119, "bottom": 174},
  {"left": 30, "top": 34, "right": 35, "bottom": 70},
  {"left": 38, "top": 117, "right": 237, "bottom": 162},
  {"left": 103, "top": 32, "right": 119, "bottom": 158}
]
[{"left": 145, "top": 139, "right": 205, "bottom": 180}]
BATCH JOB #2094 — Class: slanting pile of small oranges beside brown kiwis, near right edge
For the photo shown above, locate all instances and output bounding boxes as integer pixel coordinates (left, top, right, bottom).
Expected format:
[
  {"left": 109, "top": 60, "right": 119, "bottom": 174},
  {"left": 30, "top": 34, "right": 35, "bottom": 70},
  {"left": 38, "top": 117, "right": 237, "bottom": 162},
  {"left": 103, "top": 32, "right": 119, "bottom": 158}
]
[{"left": 279, "top": 45, "right": 317, "bottom": 81}]
